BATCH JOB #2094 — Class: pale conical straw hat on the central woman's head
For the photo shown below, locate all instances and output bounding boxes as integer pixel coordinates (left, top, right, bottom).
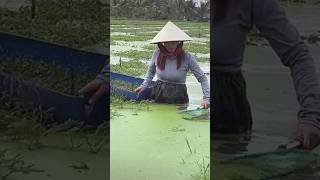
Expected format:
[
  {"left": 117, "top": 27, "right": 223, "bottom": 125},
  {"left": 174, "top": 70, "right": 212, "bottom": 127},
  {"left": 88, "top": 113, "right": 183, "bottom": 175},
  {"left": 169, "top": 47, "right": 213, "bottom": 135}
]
[{"left": 150, "top": 21, "right": 192, "bottom": 44}]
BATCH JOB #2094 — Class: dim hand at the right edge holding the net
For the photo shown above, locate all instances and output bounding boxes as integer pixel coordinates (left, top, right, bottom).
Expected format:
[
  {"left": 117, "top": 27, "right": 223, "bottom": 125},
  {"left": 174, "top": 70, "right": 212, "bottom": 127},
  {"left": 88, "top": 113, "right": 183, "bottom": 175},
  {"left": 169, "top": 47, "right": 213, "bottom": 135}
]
[{"left": 296, "top": 124, "right": 320, "bottom": 150}]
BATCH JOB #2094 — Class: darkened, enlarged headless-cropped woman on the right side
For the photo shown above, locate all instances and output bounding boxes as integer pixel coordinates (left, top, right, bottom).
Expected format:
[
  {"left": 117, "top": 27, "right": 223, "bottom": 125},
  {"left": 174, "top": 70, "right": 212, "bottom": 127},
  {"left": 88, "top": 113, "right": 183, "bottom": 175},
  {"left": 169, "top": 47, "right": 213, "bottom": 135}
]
[{"left": 211, "top": 0, "right": 320, "bottom": 149}]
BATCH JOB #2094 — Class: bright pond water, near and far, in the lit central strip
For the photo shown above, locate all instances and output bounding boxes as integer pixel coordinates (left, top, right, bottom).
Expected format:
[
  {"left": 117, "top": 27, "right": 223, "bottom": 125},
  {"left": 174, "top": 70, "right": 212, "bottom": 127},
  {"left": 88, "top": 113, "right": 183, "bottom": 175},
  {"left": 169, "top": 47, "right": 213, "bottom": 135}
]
[{"left": 110, "top": 20, "right": 210, "bottom": 180}]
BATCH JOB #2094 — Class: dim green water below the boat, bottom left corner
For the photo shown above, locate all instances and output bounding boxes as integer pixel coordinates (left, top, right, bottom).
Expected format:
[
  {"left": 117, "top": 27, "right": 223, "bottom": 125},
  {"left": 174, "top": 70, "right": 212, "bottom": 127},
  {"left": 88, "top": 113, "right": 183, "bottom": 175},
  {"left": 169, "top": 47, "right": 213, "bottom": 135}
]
[{"left": 0, "top": 135, "right": 109, "bottom": 180}]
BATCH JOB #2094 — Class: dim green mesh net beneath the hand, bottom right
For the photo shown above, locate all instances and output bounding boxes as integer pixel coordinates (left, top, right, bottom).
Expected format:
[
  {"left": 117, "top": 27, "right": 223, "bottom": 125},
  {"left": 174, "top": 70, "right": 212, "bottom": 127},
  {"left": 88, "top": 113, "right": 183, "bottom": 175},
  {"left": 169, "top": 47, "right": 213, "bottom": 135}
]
[{"left": 213, "top": 150, "right": 319, "bottom": 180}]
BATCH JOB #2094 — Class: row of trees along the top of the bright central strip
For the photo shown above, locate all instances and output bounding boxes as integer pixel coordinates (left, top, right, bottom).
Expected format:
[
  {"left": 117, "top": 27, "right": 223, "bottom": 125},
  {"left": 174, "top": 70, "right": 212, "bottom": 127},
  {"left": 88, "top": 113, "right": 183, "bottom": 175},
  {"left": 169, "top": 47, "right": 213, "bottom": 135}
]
[{"left": 111, "top": 0, "right": 210, "bottom": 21}]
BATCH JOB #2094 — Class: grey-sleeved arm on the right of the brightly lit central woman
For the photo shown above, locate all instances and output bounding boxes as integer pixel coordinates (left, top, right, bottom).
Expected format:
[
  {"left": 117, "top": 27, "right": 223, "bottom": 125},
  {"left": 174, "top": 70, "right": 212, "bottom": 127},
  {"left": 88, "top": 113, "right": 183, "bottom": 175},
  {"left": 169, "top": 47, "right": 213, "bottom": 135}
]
[{"left": 186, "top": 54, "right": 210, "bottom": 103}]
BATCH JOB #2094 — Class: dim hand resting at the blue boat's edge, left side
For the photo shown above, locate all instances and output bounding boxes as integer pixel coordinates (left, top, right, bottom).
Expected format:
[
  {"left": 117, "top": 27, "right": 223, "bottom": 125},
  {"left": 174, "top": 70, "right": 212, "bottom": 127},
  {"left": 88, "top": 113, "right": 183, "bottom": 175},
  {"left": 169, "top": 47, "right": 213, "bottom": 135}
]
[{"left": 79, "top": 79, "right": 108, "bottom": 104}]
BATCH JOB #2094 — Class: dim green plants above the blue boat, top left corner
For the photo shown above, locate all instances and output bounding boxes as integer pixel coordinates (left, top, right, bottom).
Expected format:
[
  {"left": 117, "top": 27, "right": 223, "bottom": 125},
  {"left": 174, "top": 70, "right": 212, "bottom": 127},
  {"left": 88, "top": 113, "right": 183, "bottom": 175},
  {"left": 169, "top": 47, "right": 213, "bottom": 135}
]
[{"left": 0, "top": 0, "right": 109, "bottom": 48}]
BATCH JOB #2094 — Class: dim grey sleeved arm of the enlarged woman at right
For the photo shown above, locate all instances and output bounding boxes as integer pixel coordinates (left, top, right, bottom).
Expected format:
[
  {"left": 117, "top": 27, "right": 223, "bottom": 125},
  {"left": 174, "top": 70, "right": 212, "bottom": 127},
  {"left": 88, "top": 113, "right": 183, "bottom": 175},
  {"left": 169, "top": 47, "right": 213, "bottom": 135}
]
[{"left": 253, "top": 0, "right": 320, "bottom": 146}]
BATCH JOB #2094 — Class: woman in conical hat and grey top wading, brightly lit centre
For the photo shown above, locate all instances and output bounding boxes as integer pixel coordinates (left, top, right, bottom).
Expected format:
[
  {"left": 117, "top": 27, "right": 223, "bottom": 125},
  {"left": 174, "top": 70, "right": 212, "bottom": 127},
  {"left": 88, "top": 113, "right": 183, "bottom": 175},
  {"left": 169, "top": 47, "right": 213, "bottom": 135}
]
[{"left": 135, "top": 21, "right": 210, "bottom": 108}]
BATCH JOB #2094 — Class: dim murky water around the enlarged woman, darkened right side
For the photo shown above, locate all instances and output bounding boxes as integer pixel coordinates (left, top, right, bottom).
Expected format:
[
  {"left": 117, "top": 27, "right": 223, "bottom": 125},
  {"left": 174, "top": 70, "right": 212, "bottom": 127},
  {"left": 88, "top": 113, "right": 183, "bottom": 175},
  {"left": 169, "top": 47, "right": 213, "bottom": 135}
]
[{"left": 212, "top": 5, "right": 320, "bottom": 176}]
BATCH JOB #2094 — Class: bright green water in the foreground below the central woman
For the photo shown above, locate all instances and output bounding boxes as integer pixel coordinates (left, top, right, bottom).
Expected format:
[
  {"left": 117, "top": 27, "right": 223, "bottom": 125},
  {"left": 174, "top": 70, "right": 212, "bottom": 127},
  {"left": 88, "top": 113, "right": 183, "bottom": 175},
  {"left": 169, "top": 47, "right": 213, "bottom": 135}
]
[{"left": 110, "top": 104, "right": 210, "bottom": 180}]
